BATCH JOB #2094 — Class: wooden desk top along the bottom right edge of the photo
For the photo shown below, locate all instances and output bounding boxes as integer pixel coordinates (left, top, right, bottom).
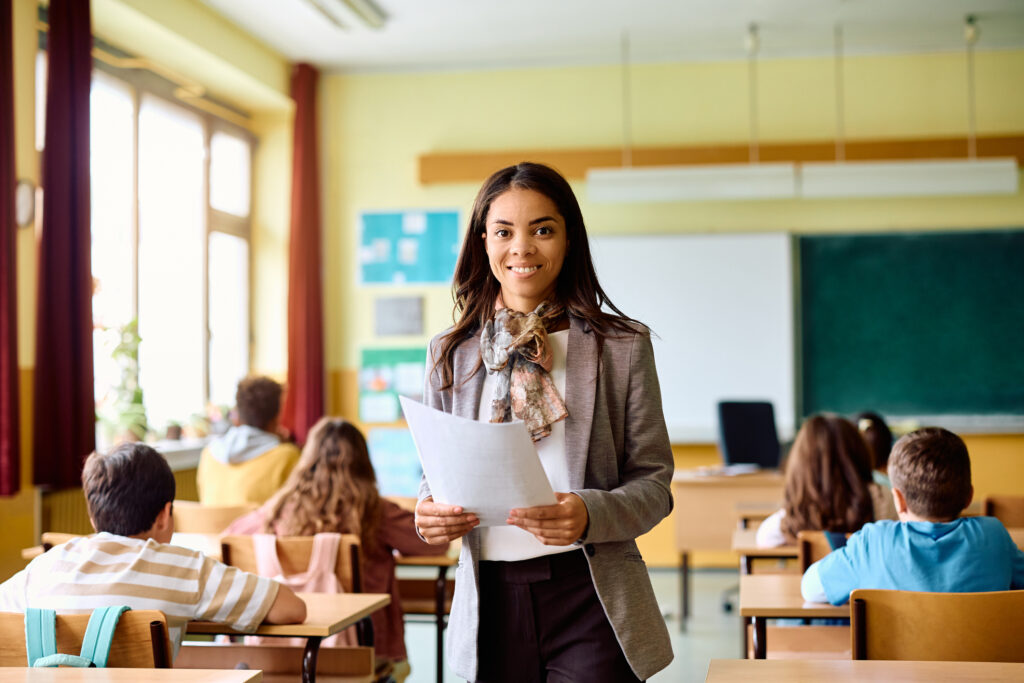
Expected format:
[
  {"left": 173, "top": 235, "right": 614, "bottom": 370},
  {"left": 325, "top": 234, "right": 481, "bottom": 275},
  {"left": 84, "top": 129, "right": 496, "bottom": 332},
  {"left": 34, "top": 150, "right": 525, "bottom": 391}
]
[{"left": 705, "top": 659, "right": 1024, "bottom": 683}]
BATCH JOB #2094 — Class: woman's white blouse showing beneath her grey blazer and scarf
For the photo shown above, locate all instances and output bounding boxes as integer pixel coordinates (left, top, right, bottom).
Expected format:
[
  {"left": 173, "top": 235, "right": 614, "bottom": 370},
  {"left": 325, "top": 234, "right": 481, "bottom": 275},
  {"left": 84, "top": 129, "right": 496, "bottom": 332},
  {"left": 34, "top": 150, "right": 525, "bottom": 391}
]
[{"left": 477, "top": 330, "right": 577, "bottom": 561}]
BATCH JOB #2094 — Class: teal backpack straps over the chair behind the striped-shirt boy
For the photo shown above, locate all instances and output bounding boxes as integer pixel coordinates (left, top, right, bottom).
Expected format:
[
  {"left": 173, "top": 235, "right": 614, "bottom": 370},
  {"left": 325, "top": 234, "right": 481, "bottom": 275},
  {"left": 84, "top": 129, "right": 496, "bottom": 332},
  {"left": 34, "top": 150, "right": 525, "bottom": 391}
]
[{"left": 25, "top": 605, "right": 131, "bottom": 668}]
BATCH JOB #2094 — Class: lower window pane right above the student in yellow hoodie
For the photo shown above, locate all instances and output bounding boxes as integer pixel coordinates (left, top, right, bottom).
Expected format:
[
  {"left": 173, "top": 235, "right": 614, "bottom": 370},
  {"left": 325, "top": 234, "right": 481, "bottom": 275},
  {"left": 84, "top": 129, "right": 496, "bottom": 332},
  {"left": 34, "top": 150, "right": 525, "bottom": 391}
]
[{"left": 210, "top": 232, "right": 249, "bottom": 405}]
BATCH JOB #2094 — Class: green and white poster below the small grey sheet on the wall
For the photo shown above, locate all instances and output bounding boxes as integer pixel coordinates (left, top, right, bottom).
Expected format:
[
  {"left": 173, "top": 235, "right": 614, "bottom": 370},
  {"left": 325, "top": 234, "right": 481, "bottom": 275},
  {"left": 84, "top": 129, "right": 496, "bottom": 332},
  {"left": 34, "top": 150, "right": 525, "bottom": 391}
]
[{"left": 359, "top": 347, "right": 427, "bottom": 422}]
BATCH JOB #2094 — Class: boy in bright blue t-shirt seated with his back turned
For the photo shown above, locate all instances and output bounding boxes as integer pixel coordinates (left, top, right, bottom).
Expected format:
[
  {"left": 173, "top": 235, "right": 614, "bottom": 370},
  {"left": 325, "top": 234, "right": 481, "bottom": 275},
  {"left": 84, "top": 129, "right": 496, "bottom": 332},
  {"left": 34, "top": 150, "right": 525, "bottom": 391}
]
[{"left": 801, "top": 427, "right": 1024, "bottom": 605}]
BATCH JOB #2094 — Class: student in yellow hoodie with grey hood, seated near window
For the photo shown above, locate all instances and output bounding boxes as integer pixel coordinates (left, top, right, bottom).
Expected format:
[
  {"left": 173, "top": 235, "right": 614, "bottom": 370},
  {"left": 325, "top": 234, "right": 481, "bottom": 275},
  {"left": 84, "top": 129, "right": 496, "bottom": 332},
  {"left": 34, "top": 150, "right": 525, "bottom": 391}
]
[{"left": 196, "top": 377, "right": 299, "bottom": 505}]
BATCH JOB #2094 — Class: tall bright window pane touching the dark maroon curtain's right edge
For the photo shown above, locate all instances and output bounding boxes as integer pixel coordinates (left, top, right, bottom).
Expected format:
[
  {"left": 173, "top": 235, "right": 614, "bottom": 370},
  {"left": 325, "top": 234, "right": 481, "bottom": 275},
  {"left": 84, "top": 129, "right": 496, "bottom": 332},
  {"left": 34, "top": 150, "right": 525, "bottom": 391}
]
[{"left": 89, "top": 72, "right": 135, "bottom": 445}]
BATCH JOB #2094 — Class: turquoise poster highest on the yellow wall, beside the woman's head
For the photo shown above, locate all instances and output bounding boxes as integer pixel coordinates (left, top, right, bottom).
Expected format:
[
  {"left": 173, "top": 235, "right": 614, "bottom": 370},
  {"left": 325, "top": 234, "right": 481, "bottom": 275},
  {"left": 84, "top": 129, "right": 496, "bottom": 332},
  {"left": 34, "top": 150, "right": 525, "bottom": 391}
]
[{"left": 359, "top": 211, "right": 459, "bottom": 285}]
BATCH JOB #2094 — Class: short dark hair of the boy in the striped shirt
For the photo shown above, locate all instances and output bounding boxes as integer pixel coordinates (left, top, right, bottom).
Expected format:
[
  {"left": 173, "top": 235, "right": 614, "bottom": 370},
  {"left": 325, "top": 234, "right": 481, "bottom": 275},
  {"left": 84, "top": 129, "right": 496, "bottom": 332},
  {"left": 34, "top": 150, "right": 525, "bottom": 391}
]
[{"left": 82, "top": 443, "right": 175, "bottom": 536}]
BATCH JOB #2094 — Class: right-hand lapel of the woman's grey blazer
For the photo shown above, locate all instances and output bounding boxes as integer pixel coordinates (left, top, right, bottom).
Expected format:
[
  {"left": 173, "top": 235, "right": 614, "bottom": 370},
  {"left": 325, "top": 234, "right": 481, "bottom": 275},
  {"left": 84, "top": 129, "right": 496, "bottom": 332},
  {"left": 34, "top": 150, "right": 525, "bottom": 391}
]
[{"left": 565, "top": 316, "right": 598, "bottom": 489}]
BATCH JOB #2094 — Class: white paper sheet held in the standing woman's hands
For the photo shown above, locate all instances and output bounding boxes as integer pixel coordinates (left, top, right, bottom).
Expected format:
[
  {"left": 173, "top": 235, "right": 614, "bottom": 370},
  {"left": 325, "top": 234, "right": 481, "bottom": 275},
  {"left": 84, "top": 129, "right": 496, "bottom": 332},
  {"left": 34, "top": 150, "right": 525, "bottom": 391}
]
[{"left": 398, "top": 396, "right": 557, "bottom": 526}]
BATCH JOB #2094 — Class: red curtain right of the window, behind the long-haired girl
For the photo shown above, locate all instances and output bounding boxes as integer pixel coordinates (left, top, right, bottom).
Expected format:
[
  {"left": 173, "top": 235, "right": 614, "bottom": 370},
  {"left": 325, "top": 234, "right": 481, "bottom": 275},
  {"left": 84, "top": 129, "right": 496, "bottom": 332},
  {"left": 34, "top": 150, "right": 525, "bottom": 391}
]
[{"left": 282, "top": 65, "right": 324, "bottom": 443}]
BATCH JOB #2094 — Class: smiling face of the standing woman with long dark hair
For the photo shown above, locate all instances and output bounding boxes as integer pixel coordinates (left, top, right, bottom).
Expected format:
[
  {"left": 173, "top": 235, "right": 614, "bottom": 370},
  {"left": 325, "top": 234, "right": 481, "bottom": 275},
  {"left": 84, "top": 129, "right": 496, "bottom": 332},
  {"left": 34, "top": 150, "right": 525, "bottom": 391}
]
[{"left": 482, "top": 189, "right": 568, "bottom": 312}]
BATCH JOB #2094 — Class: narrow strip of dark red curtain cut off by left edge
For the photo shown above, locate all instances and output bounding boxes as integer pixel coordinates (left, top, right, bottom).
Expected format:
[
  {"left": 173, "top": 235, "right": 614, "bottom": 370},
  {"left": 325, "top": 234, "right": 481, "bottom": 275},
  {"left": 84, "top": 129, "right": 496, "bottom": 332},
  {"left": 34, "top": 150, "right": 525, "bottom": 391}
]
[{"left": 0, "top": 0, "right": 22, "bottom": 496}]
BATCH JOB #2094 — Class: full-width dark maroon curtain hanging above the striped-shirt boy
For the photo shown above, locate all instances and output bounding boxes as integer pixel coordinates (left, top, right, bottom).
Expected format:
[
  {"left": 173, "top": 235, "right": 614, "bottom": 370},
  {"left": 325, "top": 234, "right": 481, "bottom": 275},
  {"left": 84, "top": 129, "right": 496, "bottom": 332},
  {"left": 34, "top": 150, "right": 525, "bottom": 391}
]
[{"left": 32, "top": 0, "right": 96, "bottom": 488}]
